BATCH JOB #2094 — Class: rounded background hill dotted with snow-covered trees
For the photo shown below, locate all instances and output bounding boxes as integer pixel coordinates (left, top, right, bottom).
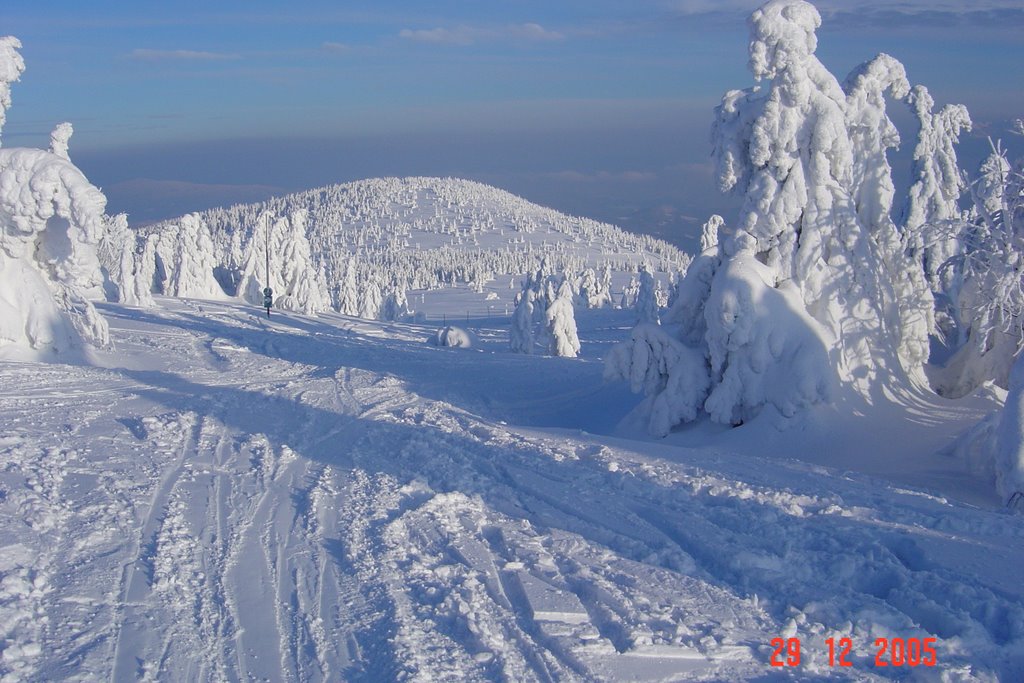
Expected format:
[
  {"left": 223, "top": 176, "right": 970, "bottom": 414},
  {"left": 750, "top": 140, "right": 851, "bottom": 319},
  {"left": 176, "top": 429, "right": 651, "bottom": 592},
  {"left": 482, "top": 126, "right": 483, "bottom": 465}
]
[{"left": 108, "top": 178, "right": 689, "bottom": 318}]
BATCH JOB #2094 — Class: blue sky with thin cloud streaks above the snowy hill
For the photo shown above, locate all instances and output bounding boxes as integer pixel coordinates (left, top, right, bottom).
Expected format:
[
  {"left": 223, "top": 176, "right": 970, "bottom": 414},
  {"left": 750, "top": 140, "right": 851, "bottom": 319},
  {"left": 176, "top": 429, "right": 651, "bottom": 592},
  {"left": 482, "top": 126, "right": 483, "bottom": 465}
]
[{"left": 0, "top": 0, "right": 1024, "bottom": 242}]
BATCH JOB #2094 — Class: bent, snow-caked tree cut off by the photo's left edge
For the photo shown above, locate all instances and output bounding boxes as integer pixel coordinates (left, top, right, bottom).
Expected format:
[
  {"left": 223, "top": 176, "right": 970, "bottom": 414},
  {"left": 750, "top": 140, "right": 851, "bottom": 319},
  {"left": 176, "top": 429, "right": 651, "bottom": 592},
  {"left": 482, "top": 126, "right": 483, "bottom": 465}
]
[{"left": 0, "top": 37, "right": 110, "bottom": 353}]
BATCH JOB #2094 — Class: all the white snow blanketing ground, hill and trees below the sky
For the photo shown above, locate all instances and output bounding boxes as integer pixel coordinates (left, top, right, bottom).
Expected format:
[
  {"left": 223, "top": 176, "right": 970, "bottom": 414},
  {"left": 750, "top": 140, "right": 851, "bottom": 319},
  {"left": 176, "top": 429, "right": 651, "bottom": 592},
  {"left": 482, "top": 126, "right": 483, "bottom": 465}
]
[{"left": 0, "top": 0, "right": 1024, "bottom": 683}]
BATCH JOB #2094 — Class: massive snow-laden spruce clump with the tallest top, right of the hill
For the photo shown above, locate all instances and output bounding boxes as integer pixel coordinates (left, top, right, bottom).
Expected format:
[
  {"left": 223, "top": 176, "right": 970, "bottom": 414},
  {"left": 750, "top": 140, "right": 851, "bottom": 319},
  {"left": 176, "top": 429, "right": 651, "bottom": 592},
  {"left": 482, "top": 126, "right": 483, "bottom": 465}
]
[{"left": 609, "top": 0, "right": 958, "bottom": 428}]
